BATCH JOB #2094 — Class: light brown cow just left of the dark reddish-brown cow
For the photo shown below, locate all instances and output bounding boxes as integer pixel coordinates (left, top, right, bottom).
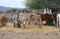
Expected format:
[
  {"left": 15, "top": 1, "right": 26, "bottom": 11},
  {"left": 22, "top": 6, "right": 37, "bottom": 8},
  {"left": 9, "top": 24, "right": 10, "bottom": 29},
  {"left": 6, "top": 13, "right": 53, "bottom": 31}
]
[{"left": 29, "top": 13, "right": 42, "bottom": 28}]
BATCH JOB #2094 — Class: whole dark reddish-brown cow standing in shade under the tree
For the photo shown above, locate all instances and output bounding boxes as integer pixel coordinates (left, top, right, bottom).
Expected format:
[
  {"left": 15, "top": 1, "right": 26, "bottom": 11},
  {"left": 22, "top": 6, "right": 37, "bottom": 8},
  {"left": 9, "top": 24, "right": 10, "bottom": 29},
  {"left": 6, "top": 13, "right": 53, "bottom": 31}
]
[{"left": 38, "top": 14, "right": 55, "bottom": 24}]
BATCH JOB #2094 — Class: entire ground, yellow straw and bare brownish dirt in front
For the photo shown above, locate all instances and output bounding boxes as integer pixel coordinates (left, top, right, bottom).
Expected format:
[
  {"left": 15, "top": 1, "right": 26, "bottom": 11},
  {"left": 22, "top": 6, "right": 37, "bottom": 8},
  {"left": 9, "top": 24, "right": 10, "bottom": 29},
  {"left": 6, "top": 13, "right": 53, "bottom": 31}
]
[{"left": 0, "top": 24, "right": 60, "bottom": 39}]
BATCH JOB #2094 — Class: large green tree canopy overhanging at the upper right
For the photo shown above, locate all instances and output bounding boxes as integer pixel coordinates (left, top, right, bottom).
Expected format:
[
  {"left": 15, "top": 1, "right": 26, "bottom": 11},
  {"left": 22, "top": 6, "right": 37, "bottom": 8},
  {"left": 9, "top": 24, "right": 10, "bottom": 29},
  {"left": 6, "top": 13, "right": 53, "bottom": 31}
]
[{"left": 25, "top": 0, "right": 60, "bottom": 9}]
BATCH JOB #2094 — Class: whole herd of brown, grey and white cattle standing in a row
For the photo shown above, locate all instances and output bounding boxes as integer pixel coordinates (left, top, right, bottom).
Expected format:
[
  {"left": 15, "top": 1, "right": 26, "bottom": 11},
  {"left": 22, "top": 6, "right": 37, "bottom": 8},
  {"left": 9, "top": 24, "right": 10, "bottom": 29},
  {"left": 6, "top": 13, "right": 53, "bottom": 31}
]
[{"left": 0, "top": 13, "right": 60, "bottom": 28}]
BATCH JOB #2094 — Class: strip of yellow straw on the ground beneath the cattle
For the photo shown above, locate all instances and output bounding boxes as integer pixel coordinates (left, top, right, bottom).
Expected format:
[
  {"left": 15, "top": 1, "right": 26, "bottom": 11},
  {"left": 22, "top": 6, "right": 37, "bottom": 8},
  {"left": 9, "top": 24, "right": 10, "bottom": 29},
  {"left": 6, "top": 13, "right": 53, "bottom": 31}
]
[{"left": 0, "top": 23, "right": 60, "bottom": 32}]
